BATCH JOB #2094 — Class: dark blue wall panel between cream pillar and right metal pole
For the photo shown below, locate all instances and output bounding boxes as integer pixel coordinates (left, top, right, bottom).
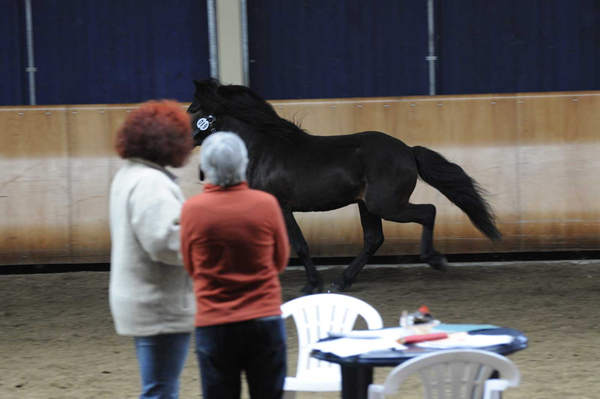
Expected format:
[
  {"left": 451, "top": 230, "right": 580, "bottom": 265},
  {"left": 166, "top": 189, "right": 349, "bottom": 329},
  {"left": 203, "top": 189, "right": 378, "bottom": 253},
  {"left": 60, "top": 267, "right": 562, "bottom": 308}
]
[{"left": 248, "top": 0, "right": 429, "bottom": 99}]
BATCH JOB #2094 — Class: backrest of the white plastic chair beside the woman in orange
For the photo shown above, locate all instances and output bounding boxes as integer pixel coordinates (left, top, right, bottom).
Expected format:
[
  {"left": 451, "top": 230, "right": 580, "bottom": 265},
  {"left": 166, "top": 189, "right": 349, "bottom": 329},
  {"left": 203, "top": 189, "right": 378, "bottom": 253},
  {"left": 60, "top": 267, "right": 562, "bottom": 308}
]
[{"left": 281, "top": 293, "right": 383, "bottom": 377}]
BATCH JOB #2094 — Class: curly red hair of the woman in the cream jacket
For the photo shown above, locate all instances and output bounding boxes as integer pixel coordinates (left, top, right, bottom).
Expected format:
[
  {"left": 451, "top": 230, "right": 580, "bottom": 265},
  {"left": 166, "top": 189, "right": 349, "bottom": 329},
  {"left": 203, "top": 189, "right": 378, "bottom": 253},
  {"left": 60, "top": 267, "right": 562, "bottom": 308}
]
[{"left": 115, "top": 100, "right": 194, "bottom": 167}]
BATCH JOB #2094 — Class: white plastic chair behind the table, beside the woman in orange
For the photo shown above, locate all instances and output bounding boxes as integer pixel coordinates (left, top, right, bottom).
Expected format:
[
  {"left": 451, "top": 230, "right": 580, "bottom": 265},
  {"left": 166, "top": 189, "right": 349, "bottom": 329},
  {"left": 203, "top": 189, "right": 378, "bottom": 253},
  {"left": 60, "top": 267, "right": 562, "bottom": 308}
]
[{"left": 281, "top": 294, "right": 383, "bottom": 399}]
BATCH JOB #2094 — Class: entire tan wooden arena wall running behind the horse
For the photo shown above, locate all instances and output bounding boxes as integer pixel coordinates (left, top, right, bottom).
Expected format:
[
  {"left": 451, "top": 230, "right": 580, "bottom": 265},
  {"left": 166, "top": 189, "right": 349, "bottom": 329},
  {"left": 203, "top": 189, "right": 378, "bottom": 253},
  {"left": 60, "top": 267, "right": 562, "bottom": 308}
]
[{"left": 0, "top": 92, "right": 600, "bottom": 264}]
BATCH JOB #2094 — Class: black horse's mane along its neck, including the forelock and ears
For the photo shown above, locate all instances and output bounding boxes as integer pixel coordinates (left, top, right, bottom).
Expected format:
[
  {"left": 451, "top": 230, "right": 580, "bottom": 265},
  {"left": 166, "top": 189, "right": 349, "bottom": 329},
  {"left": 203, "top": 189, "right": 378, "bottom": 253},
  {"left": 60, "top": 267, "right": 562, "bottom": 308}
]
[{"left": 188, "top": 79, "right": 308, "bottom": 142}]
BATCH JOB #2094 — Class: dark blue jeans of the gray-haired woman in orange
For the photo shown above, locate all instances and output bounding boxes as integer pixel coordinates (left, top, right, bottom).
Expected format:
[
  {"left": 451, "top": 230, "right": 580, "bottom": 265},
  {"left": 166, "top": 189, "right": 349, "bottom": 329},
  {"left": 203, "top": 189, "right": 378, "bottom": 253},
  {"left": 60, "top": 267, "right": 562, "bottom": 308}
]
[{"left": 196, "top": 316, "right": 287, "bottom": 399}]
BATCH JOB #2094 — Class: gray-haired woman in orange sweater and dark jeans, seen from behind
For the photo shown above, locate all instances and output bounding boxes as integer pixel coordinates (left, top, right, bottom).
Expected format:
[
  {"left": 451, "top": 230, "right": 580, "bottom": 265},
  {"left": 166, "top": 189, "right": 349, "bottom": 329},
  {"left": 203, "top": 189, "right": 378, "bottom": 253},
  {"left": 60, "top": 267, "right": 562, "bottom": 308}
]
[{"left": 181, "top": 132, "right": 290, "bottom": 399}]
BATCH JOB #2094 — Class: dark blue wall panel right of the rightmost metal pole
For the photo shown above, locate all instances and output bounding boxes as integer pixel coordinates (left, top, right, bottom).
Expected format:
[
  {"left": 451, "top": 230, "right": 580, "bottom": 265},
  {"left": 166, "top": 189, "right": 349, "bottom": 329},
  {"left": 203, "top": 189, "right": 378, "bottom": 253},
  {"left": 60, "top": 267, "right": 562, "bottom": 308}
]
[{"left": 437, "top": 0, "right": 600, "bottom": 94}]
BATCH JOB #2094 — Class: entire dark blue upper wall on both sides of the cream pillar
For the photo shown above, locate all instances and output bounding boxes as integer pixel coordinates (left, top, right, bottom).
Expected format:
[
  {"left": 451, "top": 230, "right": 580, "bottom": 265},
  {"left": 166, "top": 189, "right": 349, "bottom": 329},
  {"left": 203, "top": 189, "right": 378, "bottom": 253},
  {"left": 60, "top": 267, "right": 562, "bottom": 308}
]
[{"left": 0, "top": 0, "right": 600, "bottom": 105}]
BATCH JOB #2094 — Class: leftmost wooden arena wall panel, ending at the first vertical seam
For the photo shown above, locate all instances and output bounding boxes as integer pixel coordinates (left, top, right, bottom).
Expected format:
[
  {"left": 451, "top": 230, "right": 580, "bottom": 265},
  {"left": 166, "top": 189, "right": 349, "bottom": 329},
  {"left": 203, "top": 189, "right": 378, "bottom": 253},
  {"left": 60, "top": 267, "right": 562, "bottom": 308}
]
[{"left": 0, "top": 107, "right": 69, "bottom": 264}]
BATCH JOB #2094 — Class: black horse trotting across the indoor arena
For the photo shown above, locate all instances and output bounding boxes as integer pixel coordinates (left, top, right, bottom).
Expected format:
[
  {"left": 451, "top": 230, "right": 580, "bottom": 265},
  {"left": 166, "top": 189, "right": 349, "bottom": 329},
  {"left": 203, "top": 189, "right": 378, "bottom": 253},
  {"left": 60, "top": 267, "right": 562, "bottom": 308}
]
[{"left": 188, "top": 79, "right": 500, "bottom": 293}]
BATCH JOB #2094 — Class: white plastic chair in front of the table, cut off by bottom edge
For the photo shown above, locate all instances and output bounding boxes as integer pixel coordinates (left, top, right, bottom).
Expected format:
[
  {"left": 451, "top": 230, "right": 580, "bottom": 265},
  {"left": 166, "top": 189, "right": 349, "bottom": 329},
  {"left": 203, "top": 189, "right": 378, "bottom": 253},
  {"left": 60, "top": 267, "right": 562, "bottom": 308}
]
[{"left": 369, "top": 349, "right": 521, "bottom": 399}]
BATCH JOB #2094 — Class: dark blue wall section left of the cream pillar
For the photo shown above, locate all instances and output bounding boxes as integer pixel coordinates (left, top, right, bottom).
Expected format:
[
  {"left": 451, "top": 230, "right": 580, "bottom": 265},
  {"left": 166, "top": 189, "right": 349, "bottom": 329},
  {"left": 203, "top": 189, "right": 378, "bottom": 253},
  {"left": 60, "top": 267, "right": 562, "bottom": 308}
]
[{"left": 0, "top": 0, "right": 209, "bottom": 104}]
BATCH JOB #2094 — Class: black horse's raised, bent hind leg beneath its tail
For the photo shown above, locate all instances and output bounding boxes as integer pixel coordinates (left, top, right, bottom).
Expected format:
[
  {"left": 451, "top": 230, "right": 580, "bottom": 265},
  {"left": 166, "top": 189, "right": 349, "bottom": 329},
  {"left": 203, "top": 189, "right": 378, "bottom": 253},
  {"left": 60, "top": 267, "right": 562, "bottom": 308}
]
[{"left": 383, "top": 203, "right": 448, "bottom": 270}]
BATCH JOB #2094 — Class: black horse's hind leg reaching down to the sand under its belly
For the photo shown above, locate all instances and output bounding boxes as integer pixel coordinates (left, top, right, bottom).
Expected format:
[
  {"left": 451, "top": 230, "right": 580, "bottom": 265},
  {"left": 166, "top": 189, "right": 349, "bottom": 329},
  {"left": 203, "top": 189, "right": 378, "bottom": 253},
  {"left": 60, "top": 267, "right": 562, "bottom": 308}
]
[{"left": 331, "top": 201, "right": 383, "bottom": 291}]
